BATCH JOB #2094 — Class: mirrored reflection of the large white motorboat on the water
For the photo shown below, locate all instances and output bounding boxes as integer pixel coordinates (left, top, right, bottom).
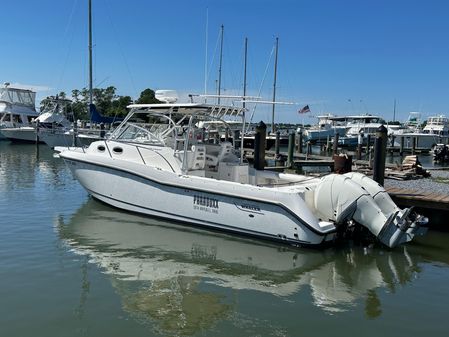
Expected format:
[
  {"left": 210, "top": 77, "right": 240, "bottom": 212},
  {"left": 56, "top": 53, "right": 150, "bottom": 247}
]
[{"left": 57, "top": 199, "right": 419, "bottom": 334}]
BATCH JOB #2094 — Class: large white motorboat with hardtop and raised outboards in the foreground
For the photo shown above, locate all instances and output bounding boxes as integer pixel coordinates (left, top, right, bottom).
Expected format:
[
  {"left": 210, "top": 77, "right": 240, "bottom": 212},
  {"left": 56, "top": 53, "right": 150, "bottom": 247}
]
[{"left": 56, "top": 103, "right": 427, "bottom": 247}]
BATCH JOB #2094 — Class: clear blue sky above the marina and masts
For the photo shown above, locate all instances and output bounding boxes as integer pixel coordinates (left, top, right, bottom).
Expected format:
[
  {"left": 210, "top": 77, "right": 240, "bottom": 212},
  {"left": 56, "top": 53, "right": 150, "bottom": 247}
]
[{"left": 0, "top": 0, "right": 449, "bottom": 123}]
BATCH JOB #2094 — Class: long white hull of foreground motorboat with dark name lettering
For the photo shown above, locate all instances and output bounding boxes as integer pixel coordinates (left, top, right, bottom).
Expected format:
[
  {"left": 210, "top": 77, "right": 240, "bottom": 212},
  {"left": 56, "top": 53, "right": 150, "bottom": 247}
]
[{"left": 63, "top": 157, "right": 335, "bottom": 246}]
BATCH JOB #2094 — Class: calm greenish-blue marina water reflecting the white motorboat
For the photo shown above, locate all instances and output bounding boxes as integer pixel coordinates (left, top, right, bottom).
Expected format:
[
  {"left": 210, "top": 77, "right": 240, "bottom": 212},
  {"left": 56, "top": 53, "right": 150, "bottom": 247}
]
[{"left": 0, "top": 142, "right": 449, "bottom": 337}]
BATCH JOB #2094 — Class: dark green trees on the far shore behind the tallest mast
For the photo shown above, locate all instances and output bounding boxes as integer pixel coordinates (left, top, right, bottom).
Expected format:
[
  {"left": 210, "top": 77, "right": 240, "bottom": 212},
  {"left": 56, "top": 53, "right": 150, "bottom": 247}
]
[{"left": 40, "top": 86, "right": 162, "bottom": 120}]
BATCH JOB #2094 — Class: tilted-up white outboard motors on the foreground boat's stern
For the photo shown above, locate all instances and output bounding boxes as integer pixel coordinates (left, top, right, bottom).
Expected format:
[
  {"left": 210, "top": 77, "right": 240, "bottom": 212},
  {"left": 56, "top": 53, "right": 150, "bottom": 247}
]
[{"left": 314, "top": 173, "right": 428, "bottom": 247}]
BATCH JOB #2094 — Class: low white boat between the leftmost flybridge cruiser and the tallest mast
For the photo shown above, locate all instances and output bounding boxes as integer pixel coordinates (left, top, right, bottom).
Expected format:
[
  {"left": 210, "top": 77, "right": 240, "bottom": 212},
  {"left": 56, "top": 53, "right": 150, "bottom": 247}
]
[{"left": 2, "top": 99, "right": 71, "bottom": 143}]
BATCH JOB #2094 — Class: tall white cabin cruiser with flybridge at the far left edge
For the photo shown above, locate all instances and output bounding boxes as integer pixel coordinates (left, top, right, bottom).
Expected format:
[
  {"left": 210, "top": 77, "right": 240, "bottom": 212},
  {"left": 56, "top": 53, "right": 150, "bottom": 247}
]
[{"left": 0, "top": 83, "right": 39, "bottom": 139}]
